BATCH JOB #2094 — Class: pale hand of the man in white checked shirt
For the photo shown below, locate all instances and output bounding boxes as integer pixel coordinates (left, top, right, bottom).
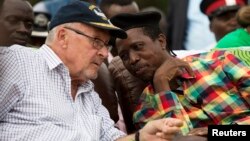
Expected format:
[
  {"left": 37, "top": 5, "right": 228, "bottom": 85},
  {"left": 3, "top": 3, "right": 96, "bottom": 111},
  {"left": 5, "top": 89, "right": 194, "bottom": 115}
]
[{"left": 140, "top": 118, "right": 183, "bottom": 141}]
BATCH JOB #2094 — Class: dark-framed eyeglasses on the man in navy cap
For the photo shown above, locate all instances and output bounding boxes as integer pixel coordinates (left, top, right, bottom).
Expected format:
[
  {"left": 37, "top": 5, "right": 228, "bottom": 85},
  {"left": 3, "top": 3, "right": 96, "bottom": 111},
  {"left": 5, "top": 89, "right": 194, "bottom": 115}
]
[{"left": 64, "top": 26, "right": 111, "bottom": 50}]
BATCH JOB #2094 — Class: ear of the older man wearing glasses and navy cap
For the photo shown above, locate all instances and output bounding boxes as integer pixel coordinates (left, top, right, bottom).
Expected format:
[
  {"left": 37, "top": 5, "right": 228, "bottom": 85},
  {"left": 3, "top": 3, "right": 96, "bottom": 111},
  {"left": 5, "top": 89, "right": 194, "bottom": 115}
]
[{"left": 56, "top": 28, "right": 69, "bottom": 48}]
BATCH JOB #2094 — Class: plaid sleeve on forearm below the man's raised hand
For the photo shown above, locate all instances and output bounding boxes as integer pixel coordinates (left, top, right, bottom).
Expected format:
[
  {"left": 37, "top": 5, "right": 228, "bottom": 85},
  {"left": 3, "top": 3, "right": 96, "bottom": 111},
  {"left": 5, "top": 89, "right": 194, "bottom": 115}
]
[{"left": 133, "top": 85, "right": 192, "bottom": 135}]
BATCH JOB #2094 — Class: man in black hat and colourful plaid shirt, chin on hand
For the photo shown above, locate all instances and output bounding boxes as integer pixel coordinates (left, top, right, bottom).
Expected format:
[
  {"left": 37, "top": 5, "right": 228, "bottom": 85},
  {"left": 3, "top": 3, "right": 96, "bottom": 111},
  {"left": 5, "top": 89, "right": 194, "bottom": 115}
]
[{"left": 111, "top": 12, "right": 250, "bottom": 135}]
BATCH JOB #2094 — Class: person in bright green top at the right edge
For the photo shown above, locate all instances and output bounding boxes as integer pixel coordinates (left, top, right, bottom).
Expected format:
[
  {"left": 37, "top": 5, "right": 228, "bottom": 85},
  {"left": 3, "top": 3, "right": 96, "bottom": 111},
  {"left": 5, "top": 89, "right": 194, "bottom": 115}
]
[{"left": 216, "top": 6, "right": 250, "bottom": 49}]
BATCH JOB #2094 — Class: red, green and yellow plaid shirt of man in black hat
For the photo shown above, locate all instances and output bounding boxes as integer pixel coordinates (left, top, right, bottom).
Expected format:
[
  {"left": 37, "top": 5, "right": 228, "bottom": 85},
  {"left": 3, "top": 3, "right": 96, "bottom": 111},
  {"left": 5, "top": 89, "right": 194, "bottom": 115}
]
[{"left": 133, "top": 50, "right": 250, "bottom": 134}]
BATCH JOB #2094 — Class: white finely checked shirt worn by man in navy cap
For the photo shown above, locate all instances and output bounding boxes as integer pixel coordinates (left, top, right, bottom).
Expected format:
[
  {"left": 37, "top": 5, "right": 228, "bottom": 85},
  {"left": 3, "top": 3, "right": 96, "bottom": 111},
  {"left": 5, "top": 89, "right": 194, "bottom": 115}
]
[{"left": 0, "top": 45, "right": 125, "bottom": 141}]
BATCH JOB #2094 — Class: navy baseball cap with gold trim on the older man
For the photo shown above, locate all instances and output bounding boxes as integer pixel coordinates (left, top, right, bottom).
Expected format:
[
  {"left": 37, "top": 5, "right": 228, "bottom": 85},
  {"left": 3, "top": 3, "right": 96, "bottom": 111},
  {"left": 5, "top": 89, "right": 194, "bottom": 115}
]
[{"left": 49, "top": 1, "right": 127, "bottom": 39}]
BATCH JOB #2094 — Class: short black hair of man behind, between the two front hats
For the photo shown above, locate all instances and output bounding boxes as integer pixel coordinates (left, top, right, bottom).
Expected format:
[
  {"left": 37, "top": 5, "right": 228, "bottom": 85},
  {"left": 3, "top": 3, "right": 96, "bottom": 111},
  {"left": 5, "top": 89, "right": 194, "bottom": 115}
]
[{"left": 100, "top": 0, "right": 134, "bottom": 10}]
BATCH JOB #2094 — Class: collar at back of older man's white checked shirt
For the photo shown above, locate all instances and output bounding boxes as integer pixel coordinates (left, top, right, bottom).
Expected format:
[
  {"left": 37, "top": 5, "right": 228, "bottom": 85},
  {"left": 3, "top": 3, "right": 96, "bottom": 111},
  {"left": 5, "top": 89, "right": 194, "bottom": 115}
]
[{"left": 39, "top": 44, "right": 63, "bottom": 70}]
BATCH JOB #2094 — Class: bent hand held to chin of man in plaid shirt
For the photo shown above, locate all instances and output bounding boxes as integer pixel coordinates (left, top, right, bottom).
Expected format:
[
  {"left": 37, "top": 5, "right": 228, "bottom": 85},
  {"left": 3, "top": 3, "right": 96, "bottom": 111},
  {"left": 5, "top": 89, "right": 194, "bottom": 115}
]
[{"left": 153, "top": 57, "right": 194, "bottom": 92}]
